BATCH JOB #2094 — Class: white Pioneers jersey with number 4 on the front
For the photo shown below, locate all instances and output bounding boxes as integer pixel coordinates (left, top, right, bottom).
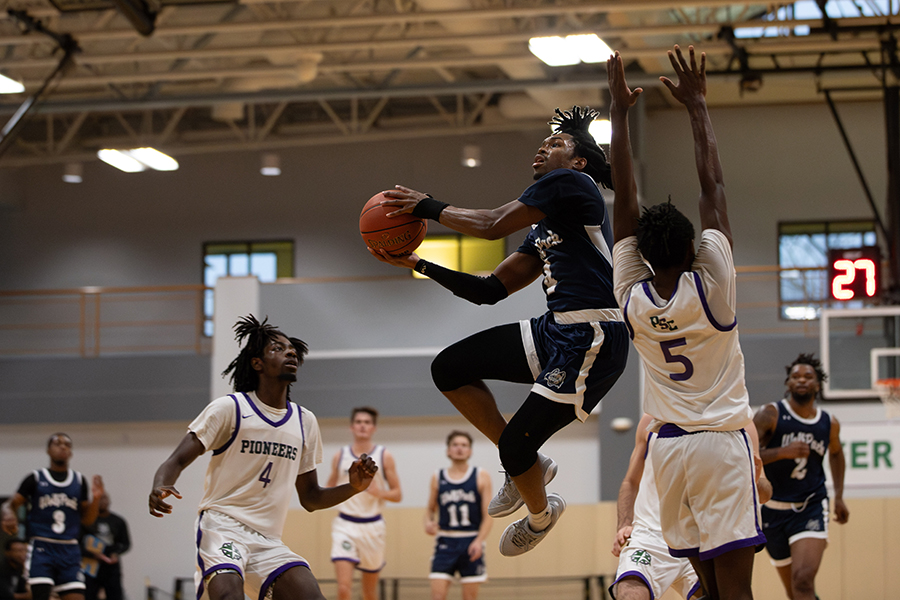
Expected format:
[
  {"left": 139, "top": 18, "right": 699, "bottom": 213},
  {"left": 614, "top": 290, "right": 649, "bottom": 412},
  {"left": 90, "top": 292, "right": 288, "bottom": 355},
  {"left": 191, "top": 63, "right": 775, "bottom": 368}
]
[{"left": 189, "top": 392, "right": 322, "bottom": 539}]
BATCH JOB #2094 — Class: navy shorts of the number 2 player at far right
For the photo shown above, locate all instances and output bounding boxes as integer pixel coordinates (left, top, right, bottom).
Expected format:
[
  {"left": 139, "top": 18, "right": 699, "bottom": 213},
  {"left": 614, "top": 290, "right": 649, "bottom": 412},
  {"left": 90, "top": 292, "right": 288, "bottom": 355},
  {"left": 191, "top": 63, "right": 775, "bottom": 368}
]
[{"left": 761, "top": 497, "right": 829, "bottom": 567}]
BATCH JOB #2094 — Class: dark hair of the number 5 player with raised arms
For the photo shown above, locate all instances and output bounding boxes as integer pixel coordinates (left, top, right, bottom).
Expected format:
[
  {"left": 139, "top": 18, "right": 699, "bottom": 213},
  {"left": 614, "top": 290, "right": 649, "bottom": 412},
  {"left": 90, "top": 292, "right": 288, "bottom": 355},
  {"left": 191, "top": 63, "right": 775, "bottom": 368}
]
[{"left": 635, "top": 196, "right": 694, "bottom": 269}]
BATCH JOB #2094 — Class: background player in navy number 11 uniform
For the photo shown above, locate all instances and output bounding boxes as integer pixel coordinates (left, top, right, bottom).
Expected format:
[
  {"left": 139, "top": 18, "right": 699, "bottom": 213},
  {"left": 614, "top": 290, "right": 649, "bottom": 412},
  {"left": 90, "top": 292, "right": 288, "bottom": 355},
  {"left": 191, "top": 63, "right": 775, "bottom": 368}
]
[{"left": 425, "top": 431, "right": 491, "bottom": 600}]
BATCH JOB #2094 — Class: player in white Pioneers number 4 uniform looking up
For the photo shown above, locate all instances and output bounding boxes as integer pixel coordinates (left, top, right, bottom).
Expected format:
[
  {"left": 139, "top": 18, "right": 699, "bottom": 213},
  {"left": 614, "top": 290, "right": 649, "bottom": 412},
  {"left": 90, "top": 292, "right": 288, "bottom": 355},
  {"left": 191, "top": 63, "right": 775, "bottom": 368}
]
[{"left": 149, "top": 315, "right": 378, "bottom": 600}]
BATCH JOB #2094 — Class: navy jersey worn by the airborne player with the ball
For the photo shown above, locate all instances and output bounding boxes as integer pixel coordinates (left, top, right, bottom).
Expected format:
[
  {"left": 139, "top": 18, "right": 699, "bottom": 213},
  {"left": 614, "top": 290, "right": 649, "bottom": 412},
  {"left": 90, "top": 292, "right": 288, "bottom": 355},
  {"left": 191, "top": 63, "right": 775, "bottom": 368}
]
[{"left": 518, "top": 169, "right": 618, "bottom": 312}]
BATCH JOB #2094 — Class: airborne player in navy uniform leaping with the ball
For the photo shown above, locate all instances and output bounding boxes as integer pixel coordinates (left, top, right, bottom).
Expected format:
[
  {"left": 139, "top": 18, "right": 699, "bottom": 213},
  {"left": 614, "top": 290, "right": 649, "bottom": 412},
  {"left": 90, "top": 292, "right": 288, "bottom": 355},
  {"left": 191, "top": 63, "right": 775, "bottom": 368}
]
[{"left": 370, "top": 106, "right": 628, "bottom": 556}]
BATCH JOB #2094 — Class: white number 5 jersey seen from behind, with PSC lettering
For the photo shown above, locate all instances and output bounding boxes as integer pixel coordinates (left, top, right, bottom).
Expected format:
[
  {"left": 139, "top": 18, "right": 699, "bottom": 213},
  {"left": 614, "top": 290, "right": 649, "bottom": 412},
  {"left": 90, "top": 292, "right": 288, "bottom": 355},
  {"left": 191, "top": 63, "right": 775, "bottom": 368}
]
[{"left": 614, "top": 229, "right": 753, "bottom": 431}]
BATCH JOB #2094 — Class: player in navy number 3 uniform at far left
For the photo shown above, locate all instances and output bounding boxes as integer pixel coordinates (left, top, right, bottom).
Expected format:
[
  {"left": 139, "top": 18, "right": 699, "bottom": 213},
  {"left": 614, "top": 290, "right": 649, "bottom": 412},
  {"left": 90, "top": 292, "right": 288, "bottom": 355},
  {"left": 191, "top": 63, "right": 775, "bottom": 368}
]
[{"left": 2, "top": 433, "right": 104, "bottom": 600}]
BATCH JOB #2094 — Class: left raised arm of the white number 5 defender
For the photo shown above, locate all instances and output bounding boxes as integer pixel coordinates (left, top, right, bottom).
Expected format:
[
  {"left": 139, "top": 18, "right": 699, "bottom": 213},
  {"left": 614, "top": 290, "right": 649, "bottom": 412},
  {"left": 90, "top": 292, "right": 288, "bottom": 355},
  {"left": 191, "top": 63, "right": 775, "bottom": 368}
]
[{"left": 606, "top": 52, "right": 643, "bottom": 242}]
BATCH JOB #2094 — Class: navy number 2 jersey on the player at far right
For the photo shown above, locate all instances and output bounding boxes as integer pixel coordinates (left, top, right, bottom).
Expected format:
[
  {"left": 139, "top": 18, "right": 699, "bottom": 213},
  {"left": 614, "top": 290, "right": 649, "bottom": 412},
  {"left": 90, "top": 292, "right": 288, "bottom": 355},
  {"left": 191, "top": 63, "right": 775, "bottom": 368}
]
[{"left": 765, "top": 400, "right": 831, "bottom": 502}]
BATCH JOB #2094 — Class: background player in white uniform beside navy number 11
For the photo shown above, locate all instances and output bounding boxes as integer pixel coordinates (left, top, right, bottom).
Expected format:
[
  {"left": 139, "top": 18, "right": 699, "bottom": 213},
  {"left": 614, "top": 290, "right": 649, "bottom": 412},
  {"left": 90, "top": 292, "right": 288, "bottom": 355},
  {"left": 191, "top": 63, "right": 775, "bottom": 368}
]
[{"left": 328, "top": 406, "right": 403, "bottom": 600}]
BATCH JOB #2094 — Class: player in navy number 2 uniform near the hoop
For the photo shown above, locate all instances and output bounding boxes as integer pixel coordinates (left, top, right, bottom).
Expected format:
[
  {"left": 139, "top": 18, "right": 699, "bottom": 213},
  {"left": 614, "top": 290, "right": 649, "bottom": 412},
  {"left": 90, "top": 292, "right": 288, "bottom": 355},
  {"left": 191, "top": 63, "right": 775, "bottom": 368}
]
[{"left": 753, "top": 354, "right": 850, "bottom": 600}]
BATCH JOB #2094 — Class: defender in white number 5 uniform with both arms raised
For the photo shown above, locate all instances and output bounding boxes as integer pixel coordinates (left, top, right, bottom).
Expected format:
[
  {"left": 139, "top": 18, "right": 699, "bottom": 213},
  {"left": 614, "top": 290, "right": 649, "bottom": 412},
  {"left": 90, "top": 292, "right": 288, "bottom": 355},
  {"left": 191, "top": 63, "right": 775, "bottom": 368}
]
[{"left": 607, "top": 46, "right": 765, "bottom": 600}]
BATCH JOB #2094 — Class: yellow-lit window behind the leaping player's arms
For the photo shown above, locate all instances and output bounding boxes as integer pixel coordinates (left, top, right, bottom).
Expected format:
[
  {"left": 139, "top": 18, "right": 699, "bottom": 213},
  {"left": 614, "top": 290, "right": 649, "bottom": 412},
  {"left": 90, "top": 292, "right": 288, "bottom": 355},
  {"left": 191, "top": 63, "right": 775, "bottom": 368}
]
[{"left": 412, "top": 233, "right": 506, "bottom": 278}]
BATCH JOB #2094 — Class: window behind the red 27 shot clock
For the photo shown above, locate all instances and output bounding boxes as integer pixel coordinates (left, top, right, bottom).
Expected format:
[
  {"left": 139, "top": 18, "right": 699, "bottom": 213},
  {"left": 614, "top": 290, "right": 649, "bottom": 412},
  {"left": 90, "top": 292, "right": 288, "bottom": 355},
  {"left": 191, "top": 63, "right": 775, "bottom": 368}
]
[{"left": 778, "top": 221, "right": 877, "bottom": 320}]
